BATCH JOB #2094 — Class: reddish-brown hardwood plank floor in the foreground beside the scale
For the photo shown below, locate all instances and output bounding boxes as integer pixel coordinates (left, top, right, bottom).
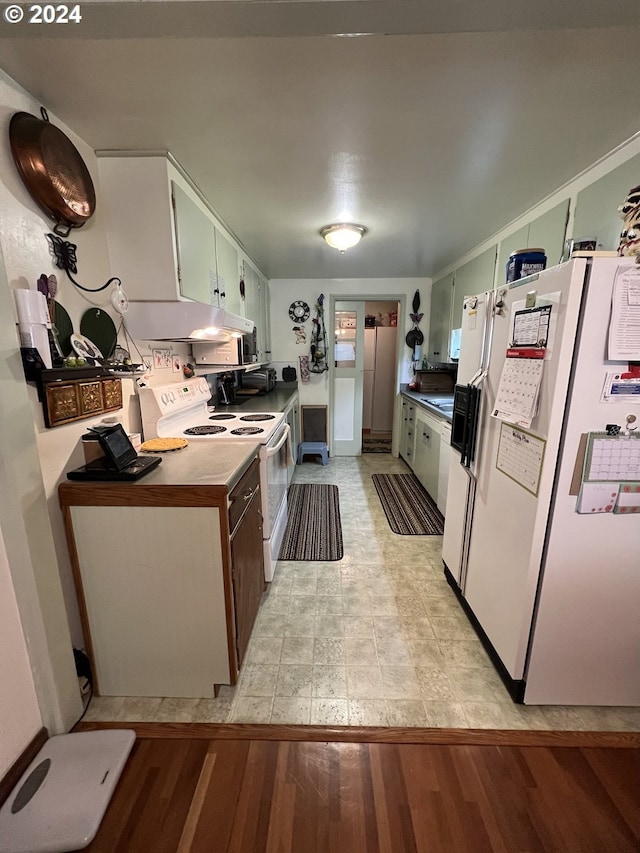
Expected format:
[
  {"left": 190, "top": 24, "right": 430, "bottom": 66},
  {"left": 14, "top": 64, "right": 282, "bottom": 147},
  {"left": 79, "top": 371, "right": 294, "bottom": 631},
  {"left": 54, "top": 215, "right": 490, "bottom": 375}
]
[{"left": 79, "top": 723, "right": 640, "bottom": 853}]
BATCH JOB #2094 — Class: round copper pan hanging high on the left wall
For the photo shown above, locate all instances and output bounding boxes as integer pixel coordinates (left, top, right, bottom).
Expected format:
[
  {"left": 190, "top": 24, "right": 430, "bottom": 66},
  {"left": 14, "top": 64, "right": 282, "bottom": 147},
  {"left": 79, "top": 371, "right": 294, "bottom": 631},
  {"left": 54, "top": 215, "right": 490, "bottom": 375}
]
[{"left": 9, "top": 111, "right": 96, "bottom": 237}]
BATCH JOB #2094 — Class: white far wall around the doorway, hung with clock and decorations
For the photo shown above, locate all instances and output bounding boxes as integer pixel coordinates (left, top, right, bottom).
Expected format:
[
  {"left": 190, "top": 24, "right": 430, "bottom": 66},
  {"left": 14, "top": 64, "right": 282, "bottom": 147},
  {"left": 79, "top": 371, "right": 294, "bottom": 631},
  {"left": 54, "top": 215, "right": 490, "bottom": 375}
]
[{"left": 269, "top": 278, "right": 431, "bottom": 405}]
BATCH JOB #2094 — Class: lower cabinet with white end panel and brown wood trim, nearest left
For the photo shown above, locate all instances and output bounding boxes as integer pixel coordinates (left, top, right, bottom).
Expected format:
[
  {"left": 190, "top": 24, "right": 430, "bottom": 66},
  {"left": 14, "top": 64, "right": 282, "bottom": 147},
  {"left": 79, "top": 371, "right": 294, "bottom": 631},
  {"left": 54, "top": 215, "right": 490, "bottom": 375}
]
[{"left": 59, "top": 458, "right": 265, "bottom": 698}]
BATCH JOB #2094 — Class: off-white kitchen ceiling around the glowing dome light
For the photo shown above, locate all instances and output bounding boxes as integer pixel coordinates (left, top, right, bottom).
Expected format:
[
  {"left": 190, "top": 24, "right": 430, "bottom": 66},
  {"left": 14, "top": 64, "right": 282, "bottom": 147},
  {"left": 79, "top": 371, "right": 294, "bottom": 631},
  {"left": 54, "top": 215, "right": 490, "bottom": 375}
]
[{"left": 0, "top": 0, "right": 640, "bottom": 278}]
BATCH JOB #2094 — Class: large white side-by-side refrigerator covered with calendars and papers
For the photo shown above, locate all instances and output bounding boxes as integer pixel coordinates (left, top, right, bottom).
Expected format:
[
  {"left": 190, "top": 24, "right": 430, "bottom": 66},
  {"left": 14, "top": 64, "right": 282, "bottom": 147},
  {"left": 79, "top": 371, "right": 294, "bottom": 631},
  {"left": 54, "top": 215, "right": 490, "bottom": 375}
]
[{"left": 442, "top": 258, "right": 640, "bottom": 706}]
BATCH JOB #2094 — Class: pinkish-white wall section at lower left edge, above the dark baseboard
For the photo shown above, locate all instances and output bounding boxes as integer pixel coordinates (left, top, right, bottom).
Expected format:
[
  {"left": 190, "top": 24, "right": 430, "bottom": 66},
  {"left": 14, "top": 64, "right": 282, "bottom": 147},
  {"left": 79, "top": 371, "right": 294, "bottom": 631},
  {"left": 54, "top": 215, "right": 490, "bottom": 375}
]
[{"left": 0, "top": 530, "right": 42, "bottom": 778}]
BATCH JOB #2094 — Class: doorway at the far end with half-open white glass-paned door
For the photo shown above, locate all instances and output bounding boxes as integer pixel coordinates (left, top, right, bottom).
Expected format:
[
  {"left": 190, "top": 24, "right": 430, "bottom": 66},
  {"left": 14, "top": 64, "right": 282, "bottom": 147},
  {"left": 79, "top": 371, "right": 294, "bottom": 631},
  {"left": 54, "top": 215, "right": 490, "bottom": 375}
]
[{"left": 330, "top": 297, "right": 400, "bottom": 456}]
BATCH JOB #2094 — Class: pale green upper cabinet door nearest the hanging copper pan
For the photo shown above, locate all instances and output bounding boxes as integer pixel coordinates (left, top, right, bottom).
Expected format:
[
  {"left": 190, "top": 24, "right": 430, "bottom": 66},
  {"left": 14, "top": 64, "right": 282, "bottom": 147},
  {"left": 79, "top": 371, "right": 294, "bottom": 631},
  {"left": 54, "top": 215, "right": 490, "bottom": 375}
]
[{"left": 171, "top": 182, "right": 217, "bottom": 304}]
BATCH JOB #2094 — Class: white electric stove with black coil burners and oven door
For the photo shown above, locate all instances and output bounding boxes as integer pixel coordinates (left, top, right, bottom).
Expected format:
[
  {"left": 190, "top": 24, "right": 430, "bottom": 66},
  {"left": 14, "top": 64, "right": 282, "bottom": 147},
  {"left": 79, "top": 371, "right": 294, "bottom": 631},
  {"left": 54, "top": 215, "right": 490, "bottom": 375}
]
[{"left": 139, "top": 377, "right": 291, "bottom": 581}]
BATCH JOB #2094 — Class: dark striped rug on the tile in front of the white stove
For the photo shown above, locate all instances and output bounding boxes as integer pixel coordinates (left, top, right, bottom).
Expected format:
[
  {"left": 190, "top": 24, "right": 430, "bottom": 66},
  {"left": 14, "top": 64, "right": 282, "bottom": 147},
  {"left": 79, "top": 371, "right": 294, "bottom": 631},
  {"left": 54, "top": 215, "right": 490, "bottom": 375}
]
[{"left": 278, "top": 483, "right": 344, "bottom": 560}]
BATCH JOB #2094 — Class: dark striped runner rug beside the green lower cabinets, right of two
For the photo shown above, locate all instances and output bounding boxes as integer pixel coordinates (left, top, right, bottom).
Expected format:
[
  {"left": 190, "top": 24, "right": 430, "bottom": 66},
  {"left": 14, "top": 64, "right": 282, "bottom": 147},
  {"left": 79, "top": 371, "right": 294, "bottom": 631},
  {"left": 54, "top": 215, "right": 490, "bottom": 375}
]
[{"left": 372, "top": 474, "right": 444, "bottom": 536}]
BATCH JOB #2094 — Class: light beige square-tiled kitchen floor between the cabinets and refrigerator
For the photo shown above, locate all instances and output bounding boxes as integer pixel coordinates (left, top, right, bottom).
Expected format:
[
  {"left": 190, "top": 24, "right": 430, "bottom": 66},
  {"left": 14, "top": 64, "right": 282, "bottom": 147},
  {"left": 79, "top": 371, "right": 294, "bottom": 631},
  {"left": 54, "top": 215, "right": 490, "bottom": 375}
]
[{"left": 85, "top": 454, "right": 640, "bottom": 731}]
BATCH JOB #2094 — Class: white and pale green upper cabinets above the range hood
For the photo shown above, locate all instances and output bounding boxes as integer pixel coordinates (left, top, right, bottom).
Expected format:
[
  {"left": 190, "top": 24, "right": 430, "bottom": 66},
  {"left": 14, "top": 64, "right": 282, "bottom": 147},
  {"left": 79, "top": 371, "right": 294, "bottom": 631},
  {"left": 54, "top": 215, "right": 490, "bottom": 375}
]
[{"left": 98, "top": 156, "right": 267, "bottom": 320}]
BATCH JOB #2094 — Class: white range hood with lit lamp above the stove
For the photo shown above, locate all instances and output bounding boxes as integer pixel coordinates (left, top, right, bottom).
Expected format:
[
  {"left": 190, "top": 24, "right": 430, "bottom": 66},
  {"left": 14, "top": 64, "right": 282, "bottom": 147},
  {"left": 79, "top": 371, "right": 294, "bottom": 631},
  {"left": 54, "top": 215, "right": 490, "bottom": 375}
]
[{"left": 125, "top": 301, "right": 254, "bottom": 343}]
